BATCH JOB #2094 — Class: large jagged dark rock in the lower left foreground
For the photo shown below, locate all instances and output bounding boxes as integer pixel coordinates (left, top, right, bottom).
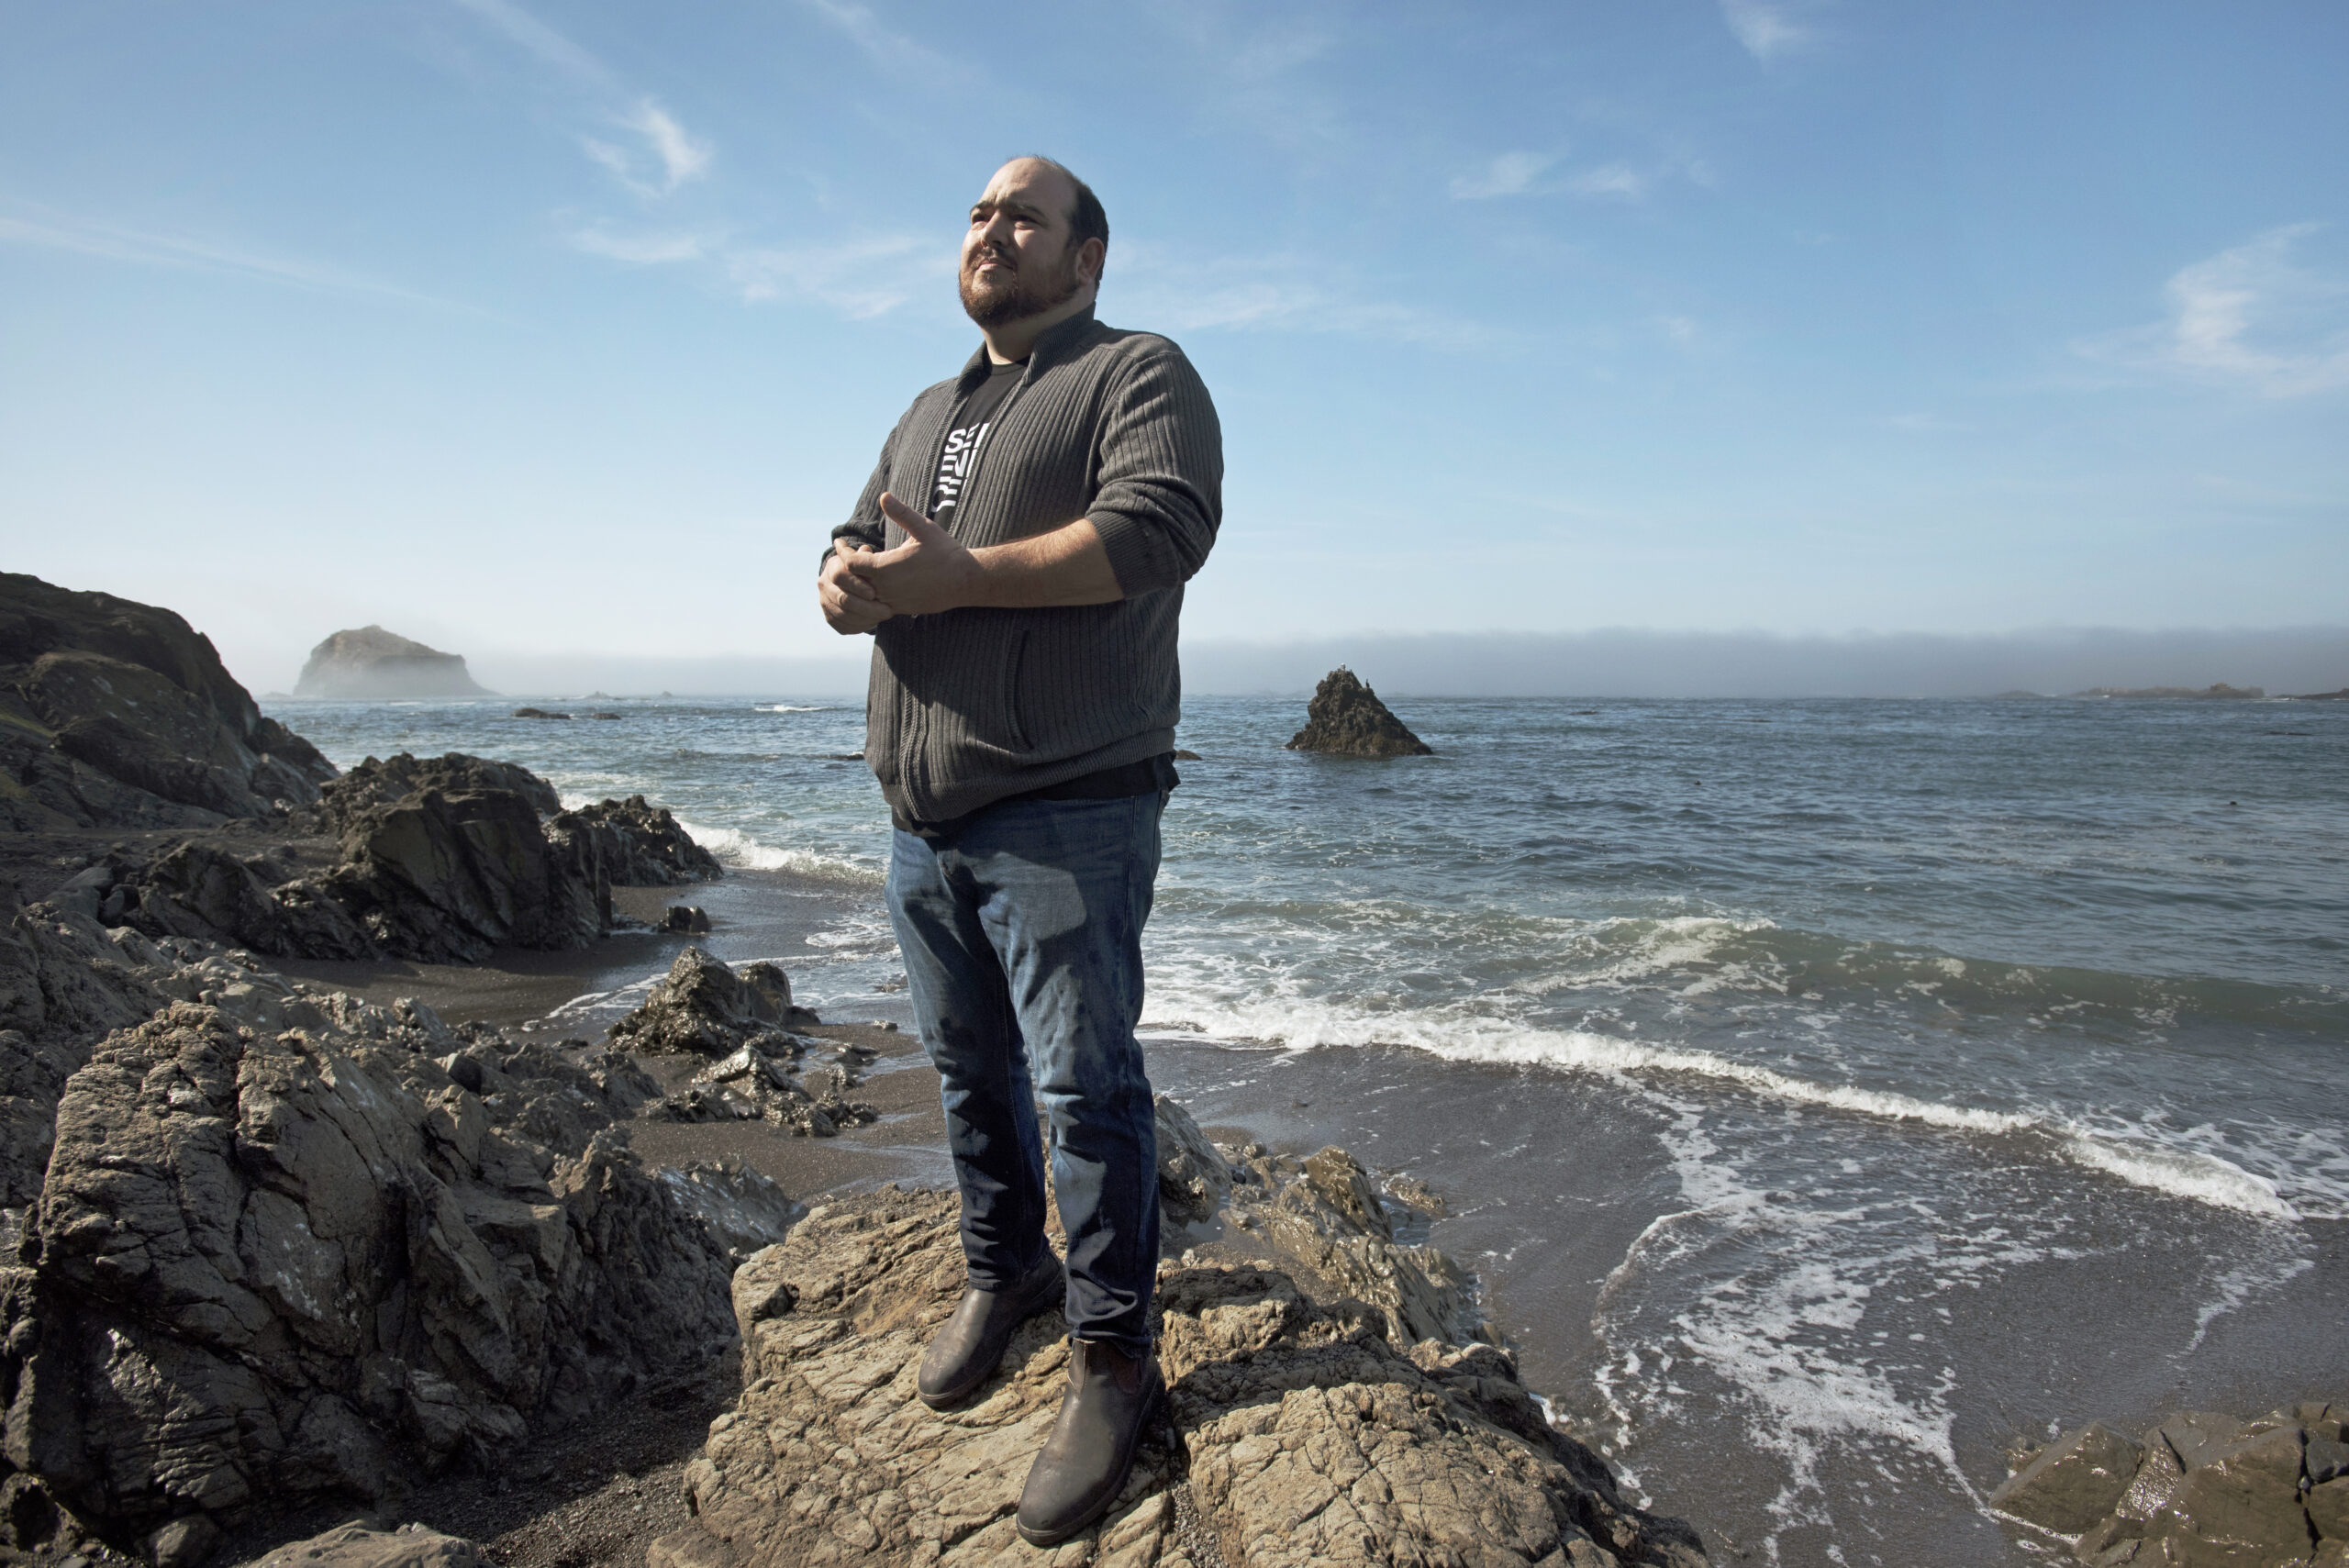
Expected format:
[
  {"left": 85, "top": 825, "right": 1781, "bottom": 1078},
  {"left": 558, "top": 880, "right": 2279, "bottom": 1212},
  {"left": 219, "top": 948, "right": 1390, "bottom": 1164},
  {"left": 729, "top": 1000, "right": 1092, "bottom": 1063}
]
[{"left": 0, "top": 958, "right": 792, "bottom": 1544}]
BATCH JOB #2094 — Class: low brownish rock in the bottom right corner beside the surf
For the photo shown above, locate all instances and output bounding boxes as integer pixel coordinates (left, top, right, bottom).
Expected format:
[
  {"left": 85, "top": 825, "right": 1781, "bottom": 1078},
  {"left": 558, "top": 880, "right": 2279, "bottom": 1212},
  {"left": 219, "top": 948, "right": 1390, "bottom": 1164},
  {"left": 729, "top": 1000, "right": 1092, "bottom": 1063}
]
[{"left": 1989, "top": 1401, "right": 2349, "bottom": 1568}]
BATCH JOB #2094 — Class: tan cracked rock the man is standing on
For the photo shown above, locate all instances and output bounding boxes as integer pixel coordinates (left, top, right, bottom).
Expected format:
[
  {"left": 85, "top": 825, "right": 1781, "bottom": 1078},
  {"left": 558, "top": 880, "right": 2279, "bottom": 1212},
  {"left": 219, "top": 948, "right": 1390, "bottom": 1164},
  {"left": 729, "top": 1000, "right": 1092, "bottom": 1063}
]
[{"left": 649, "top": 1188, "right": 1706, "bottom": 1568}]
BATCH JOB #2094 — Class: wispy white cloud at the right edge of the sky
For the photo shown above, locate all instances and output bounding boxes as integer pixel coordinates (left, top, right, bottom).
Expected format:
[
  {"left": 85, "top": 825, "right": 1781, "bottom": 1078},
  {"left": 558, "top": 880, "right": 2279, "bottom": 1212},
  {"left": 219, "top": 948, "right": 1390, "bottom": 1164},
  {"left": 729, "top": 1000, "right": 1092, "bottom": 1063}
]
[{"left": 2074, "top": 223, "right": 2349, "bottom": 396}]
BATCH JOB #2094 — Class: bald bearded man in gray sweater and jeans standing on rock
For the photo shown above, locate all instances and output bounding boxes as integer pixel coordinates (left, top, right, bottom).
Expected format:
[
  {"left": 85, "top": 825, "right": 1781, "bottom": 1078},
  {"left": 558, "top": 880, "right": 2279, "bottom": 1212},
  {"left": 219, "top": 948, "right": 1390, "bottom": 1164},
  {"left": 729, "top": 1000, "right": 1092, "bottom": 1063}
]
[{"left": 818, "top": 157, "right": 1224, "bottom": 1544}]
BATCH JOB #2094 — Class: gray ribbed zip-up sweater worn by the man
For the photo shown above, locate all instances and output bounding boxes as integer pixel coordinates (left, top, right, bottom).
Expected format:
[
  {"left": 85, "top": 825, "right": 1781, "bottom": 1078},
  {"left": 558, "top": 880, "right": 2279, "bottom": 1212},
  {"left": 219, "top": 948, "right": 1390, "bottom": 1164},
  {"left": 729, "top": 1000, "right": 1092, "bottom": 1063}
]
[{"left": 831, "top": 312, "right": 1224, "bottom": 821}]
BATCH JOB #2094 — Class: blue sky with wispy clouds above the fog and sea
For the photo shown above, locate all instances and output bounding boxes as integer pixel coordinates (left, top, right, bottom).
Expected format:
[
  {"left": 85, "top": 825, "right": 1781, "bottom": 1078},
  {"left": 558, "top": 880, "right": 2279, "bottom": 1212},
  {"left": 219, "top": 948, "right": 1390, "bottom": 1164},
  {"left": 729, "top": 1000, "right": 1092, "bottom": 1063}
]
[{"left": 0, "top": 0, "right": 2349, "bottom": 688}]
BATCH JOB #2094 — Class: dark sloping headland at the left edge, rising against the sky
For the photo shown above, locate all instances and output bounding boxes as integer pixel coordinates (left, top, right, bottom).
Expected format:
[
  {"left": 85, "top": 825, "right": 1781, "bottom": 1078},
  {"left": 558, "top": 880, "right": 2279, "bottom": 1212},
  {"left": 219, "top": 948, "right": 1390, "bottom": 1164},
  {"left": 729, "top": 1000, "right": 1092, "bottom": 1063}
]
[{"left": 0, "top": 573, "right": 334, "bottom": 831}]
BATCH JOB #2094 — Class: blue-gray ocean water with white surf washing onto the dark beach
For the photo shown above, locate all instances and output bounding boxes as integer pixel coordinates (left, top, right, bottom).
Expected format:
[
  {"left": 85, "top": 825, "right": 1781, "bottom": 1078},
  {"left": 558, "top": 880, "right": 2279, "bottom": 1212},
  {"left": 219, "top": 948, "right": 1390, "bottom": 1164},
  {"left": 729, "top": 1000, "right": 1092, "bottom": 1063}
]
[{"left": 277, "top": 695, "right": 2349, "bottom": 1563}]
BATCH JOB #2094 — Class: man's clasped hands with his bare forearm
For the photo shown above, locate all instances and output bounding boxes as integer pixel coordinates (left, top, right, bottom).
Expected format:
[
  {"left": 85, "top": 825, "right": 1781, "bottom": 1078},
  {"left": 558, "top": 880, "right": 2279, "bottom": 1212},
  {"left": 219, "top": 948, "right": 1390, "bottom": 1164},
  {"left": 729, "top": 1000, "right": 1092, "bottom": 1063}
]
[{"left": 815, "top": 493, "right": 1125, "bottom": 636}]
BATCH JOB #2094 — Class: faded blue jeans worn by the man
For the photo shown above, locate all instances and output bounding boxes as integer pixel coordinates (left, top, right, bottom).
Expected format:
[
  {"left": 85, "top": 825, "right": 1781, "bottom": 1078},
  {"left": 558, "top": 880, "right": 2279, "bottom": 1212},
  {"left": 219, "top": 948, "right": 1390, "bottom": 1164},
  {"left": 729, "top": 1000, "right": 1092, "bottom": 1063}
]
[{"left": 888, "top": 791, "right": 1165, "bottom": 1352}]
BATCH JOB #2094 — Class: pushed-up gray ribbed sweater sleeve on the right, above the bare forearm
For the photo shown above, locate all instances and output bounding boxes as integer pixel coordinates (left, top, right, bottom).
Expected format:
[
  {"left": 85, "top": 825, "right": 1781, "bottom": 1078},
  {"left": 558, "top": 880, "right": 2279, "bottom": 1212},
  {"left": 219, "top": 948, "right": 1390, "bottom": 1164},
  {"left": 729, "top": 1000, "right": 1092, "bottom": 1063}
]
[{"left": 1085, "top": 343, "right": 1224, "bottom": 598}]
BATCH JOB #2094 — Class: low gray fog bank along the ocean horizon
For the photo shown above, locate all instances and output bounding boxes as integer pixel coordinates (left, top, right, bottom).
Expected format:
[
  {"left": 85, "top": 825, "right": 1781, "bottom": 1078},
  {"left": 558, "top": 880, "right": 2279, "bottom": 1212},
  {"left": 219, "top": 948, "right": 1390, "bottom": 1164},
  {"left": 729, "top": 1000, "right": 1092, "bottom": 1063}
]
[{"left": 422, "top": 627, "right": 2349, "bottom": 697}]
